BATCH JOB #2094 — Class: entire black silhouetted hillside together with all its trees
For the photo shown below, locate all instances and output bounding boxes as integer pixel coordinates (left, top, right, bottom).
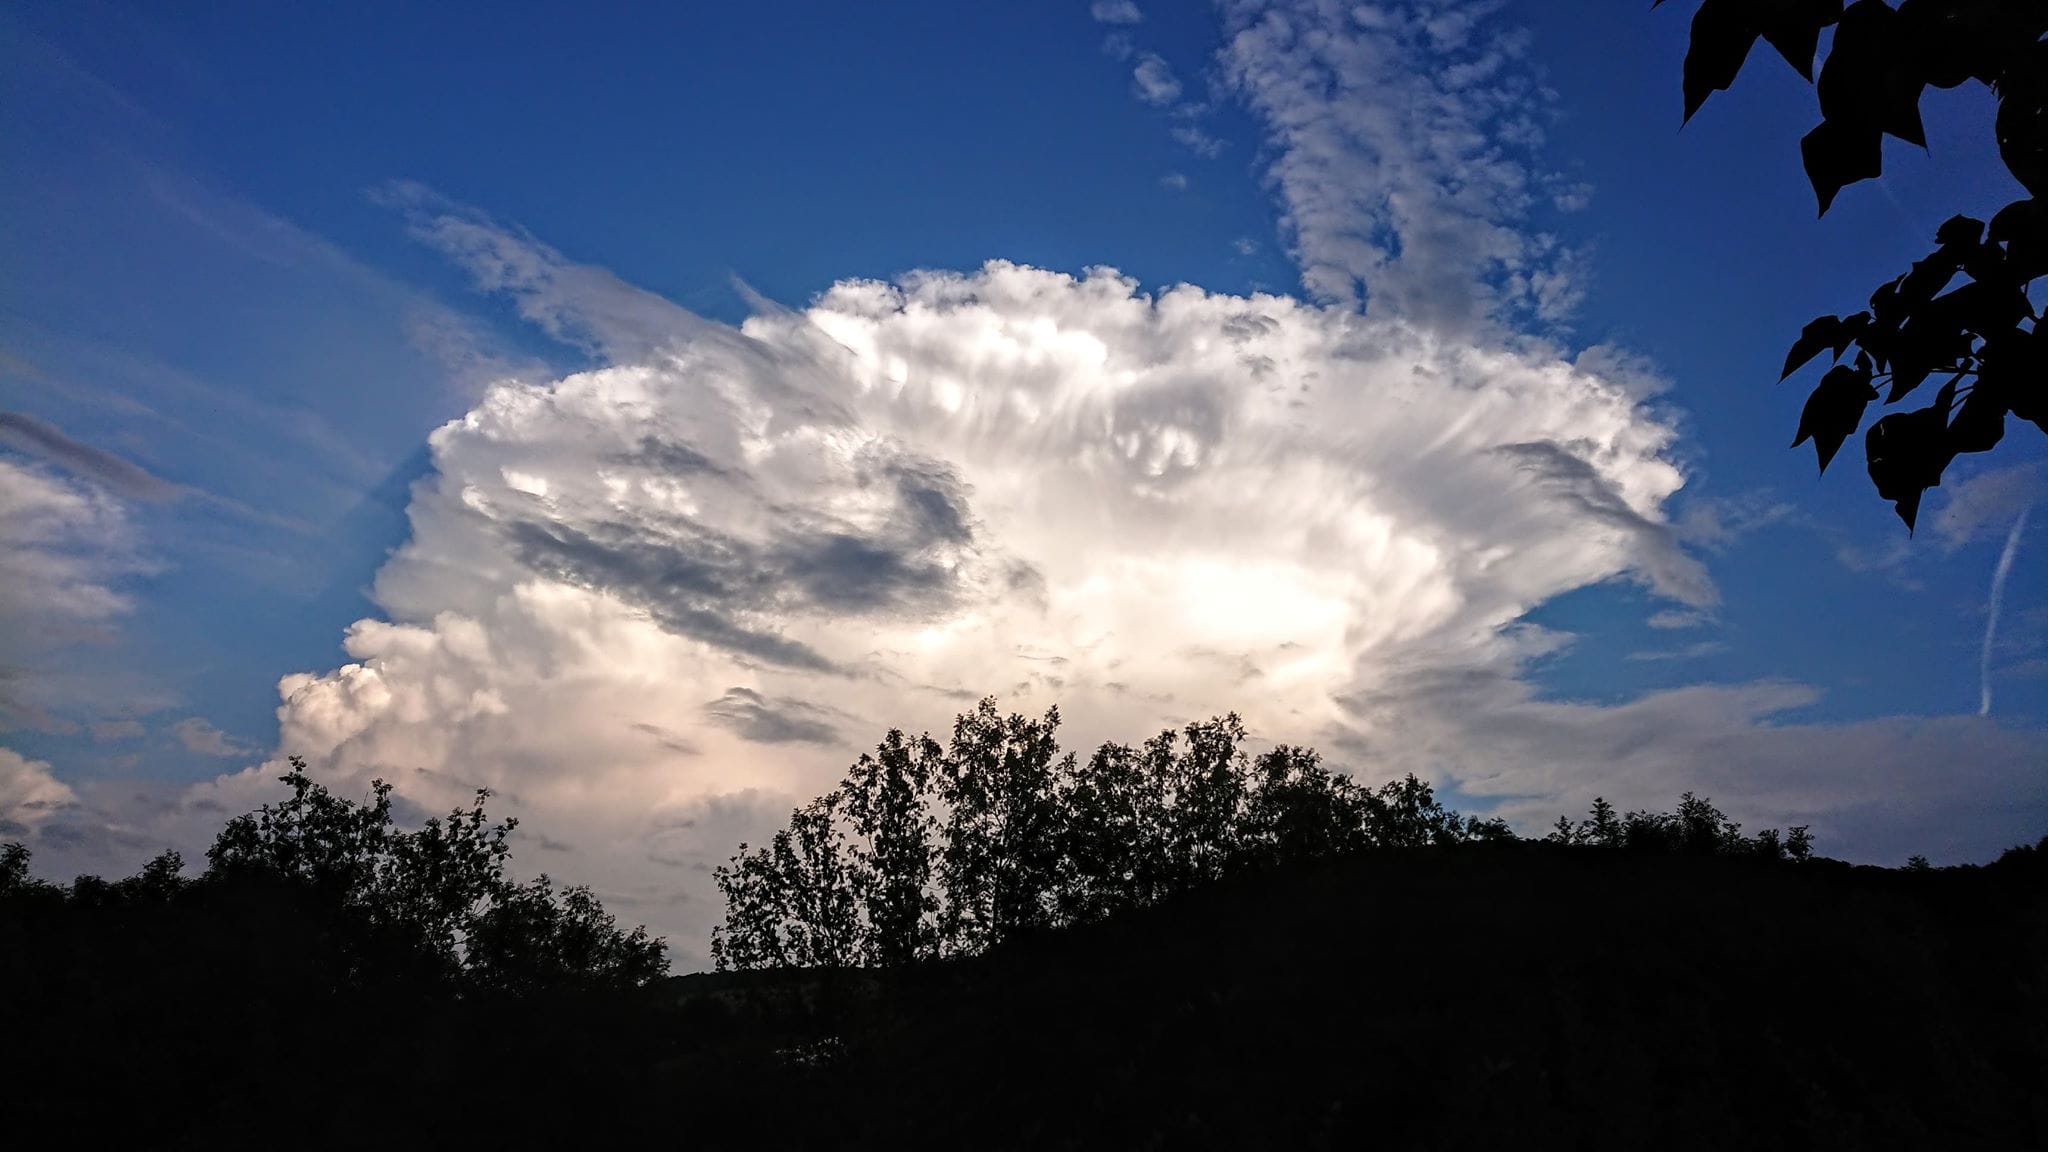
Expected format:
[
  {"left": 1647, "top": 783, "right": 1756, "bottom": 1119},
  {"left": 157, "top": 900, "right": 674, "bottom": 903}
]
[{"left": 0, "top": 701, "right": 2048, "bottom": 1150}]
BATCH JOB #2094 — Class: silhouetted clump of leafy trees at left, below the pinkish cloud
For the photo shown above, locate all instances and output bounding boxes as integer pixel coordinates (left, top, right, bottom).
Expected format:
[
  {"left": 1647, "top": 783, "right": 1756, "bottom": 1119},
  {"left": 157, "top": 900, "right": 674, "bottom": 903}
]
[{"left": 0, "top": 756, "right": 668, "bottom": 996}]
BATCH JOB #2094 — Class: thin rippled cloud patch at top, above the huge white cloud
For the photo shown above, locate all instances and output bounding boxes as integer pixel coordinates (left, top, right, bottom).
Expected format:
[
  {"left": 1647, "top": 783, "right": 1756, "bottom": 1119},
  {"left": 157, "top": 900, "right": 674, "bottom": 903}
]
[{"left": 1223, "top": 0, "right": 1583, "bottom": 334}]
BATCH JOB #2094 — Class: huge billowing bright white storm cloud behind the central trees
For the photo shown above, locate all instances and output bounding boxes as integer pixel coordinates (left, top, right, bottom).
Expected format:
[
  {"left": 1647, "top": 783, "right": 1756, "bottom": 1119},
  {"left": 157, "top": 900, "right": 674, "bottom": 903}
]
[{"left": 220, "top": 213, "right": 1714, "bottom": 951}]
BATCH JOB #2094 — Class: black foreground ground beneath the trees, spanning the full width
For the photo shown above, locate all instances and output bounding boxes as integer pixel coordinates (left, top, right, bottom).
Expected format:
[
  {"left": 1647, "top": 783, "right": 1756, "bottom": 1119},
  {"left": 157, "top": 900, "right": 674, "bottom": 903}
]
[{"left": 0, "top": 842, "right": 2048, "bottom": 1150}]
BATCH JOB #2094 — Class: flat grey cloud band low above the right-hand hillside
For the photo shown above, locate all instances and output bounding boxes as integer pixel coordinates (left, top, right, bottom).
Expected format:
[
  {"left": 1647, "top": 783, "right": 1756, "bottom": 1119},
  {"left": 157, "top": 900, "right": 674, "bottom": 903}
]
[{"left": 1358, "top": 678, "right": 2048, "bottom": 863}]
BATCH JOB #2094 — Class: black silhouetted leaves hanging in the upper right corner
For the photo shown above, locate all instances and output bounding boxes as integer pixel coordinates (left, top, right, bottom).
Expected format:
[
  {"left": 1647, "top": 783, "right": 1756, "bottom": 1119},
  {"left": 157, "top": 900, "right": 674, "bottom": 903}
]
[{"left": 1653, "top": 0, "right": 2048, "bottom": 531}]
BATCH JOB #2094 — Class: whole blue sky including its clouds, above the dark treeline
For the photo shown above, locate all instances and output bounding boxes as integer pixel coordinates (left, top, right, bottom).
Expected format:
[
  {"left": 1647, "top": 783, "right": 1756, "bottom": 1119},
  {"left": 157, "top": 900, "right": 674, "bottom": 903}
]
[{"left": 0, "top": 0, "right": 2048, "bottom": 947}]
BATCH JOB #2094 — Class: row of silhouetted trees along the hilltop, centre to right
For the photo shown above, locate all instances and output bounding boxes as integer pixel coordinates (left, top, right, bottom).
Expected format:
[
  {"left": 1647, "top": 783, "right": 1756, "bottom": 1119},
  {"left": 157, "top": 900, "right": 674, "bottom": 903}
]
[{"left": 711, "top": 697, "right": 1810, "bottom": 972}]
